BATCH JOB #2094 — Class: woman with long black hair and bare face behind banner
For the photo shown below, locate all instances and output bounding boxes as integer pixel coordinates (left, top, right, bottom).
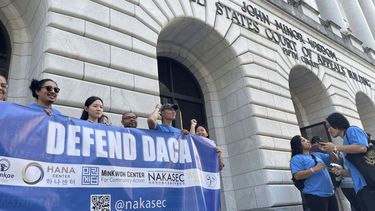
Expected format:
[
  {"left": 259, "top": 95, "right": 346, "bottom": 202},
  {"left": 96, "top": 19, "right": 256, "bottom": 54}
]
[{"left": 81, "top": 96, "right": 104, "bottom": 123}]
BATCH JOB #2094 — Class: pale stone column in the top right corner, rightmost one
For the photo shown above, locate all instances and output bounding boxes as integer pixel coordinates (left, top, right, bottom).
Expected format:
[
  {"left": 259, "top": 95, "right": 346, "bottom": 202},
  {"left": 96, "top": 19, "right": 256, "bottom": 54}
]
[{"left": 339, "top": 0, "right": 375, "bottom": 49}]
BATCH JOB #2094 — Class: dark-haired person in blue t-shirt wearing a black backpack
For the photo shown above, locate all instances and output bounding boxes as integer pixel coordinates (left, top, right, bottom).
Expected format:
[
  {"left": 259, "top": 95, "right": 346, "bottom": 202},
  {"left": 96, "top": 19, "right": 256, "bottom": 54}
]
[{"left": 323, "top": 113, "right": 375, "bottom": 211}]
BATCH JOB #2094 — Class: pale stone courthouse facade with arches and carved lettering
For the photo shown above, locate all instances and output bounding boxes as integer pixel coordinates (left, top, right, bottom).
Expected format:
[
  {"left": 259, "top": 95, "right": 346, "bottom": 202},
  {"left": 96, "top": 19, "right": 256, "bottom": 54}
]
[{"left": 0, "top": 0, "right": 375, "bottom": 210}]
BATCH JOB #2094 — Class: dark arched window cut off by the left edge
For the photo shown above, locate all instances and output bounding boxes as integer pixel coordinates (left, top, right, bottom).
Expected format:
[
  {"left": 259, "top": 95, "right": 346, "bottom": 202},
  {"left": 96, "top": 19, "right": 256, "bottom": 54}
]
[{"left": 0, "top": 22, "right": 11, "bottom": 77}]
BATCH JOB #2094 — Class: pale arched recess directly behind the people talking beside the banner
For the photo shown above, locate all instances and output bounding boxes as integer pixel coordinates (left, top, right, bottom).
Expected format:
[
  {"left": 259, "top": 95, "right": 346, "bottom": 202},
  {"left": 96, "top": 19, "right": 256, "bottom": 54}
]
[{"left": 289, "top": 66, "right": 334, "bottom": 140}]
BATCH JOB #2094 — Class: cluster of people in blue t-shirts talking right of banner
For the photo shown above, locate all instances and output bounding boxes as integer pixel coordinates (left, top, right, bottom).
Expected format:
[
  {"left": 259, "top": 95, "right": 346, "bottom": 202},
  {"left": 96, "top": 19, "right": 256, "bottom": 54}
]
[{"left": 290, "top": 113, "right": 375, "bottom": 211}]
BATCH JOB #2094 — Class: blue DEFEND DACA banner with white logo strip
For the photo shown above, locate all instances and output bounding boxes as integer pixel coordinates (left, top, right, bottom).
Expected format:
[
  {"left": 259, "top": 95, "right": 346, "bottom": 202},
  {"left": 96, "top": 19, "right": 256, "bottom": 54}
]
[{"left": 0, "top": 102, "right": 220, "bottom": 211}]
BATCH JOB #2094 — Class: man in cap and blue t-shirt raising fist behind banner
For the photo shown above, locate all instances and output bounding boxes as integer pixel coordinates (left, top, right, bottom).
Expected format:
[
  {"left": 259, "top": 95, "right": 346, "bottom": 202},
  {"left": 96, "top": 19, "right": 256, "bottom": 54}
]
[{"left": 147, "top": 103, "right": 189, "bottom": 134}]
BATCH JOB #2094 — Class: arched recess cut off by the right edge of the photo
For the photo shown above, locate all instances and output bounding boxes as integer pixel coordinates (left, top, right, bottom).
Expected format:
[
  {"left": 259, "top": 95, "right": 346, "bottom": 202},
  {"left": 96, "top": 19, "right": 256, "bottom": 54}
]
[{"left": 355, "top": 92, "right": 375, "bottom": 135}]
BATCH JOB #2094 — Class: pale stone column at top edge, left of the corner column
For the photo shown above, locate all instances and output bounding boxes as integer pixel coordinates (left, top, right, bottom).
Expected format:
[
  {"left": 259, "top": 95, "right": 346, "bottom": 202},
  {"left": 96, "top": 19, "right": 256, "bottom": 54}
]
[{"left": 316, "top": 0, "right": 347, "bottom": 32}]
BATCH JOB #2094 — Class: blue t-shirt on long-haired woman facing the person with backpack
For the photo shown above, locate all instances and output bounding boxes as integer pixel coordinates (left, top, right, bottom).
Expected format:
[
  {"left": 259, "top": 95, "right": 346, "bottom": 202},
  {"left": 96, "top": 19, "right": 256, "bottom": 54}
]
[{"left": 290, "top": 152, "right": 334, "bottom": 197}]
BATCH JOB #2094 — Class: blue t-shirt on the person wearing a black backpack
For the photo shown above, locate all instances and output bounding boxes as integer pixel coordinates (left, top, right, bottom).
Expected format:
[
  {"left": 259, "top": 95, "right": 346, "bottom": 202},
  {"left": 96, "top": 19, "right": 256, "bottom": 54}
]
[{"left": 343, "top": 126, "right": 368, "bottom": 193}]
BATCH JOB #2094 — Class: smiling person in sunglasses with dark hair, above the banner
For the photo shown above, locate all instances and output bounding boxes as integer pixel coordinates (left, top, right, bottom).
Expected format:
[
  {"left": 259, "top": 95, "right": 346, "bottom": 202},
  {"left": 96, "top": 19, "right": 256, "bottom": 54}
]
[{"left": 29, "top": 79, "right": 61, "bottom": 115}]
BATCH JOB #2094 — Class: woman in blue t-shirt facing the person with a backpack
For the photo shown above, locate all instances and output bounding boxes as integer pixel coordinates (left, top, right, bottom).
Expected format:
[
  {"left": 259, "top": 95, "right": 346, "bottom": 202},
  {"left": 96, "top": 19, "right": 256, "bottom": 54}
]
[{"left": 290, "top": 135, "right": 339, "bottom": 211}]
